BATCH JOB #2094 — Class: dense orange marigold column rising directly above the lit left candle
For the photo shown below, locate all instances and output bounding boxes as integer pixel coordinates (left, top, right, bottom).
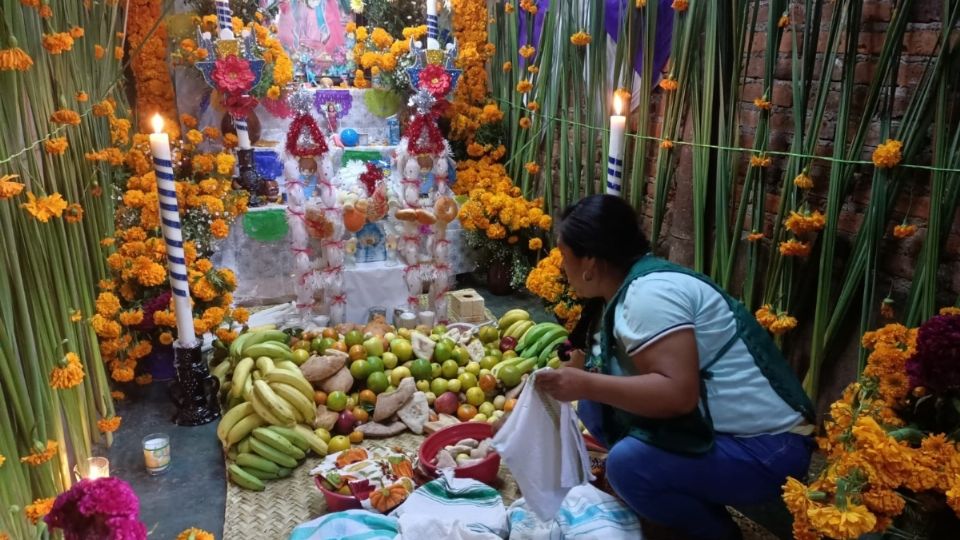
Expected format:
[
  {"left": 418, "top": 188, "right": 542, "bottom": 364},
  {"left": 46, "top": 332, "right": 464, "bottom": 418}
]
[{"left": 127, "top": 0, "right": 179, "bottom": 139}]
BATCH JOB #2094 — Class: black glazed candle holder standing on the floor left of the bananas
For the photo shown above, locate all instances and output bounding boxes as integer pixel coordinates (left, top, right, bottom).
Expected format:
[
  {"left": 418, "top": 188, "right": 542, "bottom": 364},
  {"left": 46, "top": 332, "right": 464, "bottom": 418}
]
[{"left": 171, "top": 342, "right": 220, "bottom": 426}]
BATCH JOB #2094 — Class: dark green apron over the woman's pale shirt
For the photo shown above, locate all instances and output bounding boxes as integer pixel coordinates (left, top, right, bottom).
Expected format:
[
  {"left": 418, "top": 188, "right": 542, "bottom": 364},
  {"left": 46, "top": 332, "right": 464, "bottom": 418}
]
[{"left": 600, "top": 255, "right": 814, "bottom": 455}]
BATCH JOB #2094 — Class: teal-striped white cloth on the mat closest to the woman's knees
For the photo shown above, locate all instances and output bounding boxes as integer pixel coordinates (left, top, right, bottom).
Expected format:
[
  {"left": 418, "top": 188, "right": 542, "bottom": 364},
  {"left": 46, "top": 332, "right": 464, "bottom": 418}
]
[{"left": 507, "top": 484, "right": 643, "bottom": 540}]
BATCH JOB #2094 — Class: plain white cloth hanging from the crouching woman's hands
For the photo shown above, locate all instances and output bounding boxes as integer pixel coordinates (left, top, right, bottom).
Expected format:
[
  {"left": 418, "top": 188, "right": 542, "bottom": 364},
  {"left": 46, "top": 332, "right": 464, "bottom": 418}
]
[{"left": 493, "top": 368, "right": 593, "bottom": 521}]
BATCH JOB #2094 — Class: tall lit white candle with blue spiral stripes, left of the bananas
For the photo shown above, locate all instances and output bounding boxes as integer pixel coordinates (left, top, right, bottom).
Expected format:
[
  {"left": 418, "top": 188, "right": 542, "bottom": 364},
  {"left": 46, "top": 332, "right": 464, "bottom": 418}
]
[{"left": 150, "top": 114, "right": 197, "bottom": 347}]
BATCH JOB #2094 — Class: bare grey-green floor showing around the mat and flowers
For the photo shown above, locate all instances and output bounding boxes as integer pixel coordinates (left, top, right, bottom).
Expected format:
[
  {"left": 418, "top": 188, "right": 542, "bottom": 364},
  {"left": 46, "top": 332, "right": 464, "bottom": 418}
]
[{"left": 108, "top": 276, "right": 790, "bottom": 540}]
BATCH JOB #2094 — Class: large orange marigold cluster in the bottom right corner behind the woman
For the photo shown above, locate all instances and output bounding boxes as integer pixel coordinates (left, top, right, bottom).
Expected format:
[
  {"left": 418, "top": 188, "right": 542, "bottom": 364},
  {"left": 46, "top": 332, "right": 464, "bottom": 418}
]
[{"left": 783, "top": 324, "right": 960, "bottom": 538}]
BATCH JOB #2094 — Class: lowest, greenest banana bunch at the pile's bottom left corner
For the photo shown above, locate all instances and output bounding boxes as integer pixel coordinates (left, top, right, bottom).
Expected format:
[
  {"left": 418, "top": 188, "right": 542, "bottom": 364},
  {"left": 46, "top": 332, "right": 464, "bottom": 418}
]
[{"left": 227, "top": 426, "right": 327, "bottom": 491}]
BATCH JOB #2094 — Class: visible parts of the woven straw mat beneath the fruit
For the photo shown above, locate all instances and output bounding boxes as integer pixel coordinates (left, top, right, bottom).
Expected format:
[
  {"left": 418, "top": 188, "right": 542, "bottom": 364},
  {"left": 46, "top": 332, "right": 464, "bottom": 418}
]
[{"left": 223, "top": 433, "right": 520, "bottom": 540}]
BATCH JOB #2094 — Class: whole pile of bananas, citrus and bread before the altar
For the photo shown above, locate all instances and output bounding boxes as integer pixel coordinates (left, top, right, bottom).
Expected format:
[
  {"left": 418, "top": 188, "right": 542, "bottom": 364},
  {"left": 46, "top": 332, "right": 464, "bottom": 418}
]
[{"left": 212, "top": 309, "right": 567, "bottom": 489}]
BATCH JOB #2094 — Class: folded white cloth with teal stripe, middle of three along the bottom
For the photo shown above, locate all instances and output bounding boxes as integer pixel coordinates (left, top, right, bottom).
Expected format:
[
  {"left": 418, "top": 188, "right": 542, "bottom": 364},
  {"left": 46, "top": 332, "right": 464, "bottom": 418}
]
[{"left": 390, "top": 470, "right": 509, "bottom": 540}]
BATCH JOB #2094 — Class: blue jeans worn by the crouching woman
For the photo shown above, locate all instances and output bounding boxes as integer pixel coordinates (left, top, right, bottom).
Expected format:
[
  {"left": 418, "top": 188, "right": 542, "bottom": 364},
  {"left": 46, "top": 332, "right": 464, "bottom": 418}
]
[{"left": 577, "top": 401, "right": 813, "bottom": 540}]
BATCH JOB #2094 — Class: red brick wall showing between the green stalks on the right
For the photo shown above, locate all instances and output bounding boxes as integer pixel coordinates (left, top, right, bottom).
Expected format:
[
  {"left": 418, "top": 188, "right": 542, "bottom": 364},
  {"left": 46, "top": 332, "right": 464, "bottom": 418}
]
[{"left": 645, "top": 0, "right": 960, "bottom": 406}]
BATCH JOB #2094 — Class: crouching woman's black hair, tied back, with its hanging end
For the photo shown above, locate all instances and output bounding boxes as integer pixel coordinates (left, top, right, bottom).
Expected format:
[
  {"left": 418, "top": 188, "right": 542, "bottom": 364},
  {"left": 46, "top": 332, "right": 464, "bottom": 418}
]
[{"left": 559, "top": 195, "right": 650, "bottom": 352}]
